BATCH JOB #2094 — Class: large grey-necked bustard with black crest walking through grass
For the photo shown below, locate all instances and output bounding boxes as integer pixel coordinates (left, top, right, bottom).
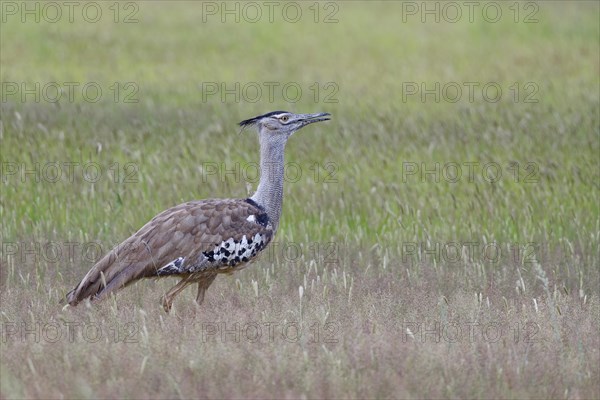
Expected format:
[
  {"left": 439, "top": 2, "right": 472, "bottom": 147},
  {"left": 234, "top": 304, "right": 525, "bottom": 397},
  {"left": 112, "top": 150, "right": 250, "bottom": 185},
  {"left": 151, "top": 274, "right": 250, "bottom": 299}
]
[{"left": 66, "top": 111, "right": 331, "bottom": 313}]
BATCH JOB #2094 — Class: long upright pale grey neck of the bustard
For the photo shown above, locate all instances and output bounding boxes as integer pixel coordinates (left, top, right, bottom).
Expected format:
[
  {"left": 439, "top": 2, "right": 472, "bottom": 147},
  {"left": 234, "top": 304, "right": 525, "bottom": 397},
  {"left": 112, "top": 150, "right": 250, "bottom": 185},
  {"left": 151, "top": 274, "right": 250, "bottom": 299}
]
[{"left": 251, "top": 138, "right": 285, "bottom": 231}]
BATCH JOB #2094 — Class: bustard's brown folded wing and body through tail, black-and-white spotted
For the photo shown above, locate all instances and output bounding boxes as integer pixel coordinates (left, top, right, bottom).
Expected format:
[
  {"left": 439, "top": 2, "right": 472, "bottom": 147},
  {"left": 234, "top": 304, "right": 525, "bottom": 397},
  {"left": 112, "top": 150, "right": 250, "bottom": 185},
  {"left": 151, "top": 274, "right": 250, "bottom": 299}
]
[{"left": 67, "top": 199, "right": 273, "bottom": 305}]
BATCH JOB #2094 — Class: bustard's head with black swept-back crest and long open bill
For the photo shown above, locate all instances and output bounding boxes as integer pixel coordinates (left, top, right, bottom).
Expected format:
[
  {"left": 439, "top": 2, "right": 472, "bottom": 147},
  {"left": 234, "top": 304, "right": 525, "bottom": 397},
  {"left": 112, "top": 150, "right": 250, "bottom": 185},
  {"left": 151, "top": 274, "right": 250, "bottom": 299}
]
[{"left": 240, "top": 111, "right": 330, "bottom": 142}]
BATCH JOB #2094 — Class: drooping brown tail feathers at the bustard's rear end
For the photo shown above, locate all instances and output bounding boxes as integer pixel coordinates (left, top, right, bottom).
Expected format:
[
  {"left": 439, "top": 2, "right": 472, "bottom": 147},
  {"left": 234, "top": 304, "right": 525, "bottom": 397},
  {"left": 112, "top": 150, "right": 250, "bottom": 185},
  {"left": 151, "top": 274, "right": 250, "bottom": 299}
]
[{"left": 66, "top": 244, "right": 142, "bottom": 306}]
